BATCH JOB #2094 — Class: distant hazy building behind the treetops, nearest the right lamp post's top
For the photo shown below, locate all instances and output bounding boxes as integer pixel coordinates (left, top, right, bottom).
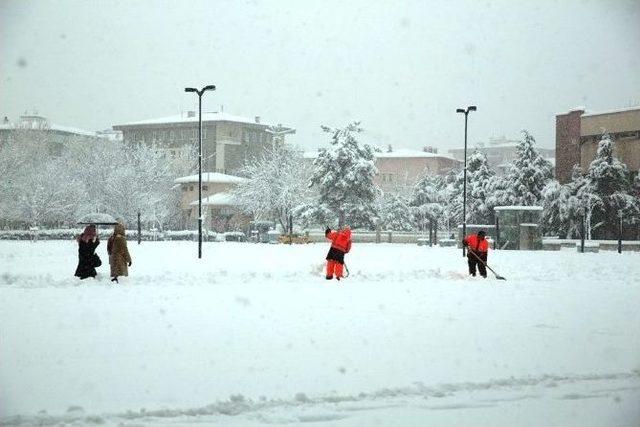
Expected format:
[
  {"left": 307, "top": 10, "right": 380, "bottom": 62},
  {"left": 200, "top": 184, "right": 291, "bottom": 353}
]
[{"left": 449, "top": 136, "right": 555, "bottom": 175}]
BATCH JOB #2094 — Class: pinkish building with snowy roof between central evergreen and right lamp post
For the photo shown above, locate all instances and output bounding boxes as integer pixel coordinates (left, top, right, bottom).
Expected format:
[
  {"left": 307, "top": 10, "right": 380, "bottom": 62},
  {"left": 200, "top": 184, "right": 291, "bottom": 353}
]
[{"left": 303, "top": 147, "right": 461, "bottom": 192}]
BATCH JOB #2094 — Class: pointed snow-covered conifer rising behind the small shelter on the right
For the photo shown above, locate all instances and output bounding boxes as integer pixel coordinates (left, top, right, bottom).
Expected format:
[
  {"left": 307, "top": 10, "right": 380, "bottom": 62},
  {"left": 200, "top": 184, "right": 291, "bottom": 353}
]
[{"left": 489, "top": 130, "right": 553, "bottom": 206}]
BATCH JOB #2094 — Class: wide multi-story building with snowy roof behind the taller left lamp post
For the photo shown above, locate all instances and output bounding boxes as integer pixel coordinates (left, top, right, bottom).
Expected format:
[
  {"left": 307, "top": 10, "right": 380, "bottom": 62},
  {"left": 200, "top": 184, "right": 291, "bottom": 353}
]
[{"left": 113, "top": 111, "right": 295, "bottom": 173}]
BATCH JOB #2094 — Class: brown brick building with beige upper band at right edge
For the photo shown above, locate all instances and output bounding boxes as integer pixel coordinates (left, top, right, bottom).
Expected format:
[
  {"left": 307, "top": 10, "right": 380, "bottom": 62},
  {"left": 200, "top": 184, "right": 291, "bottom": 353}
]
[{"left": 556, "top": 107, "right": 640, "bottom": 183}]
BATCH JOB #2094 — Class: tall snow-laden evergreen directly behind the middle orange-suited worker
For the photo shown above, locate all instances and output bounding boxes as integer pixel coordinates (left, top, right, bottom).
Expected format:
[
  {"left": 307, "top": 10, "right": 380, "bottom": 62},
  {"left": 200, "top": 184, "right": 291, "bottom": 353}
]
[{"left": 310, "top": 122, "right": 380, "bottom": 228}]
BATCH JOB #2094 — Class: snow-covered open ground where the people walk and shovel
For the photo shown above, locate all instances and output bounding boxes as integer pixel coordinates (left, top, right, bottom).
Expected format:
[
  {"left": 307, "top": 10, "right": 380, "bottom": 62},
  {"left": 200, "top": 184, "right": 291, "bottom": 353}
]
[{"left": 0, "top": 241, "right": 640, "bottom": 427}]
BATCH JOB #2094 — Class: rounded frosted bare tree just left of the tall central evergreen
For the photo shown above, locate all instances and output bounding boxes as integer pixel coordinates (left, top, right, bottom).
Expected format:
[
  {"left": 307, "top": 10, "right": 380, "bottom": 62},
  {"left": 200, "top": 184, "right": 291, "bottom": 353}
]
[{"left": 234, "top": 144, "right": 310, "bottom": 230}]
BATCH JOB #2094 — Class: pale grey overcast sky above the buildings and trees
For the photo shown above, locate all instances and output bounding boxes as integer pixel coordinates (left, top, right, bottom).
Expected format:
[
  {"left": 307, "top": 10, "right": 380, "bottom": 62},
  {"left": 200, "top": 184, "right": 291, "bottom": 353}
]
[{"left": 0, "top": 0, "right": 640, "bottom": 152}]
